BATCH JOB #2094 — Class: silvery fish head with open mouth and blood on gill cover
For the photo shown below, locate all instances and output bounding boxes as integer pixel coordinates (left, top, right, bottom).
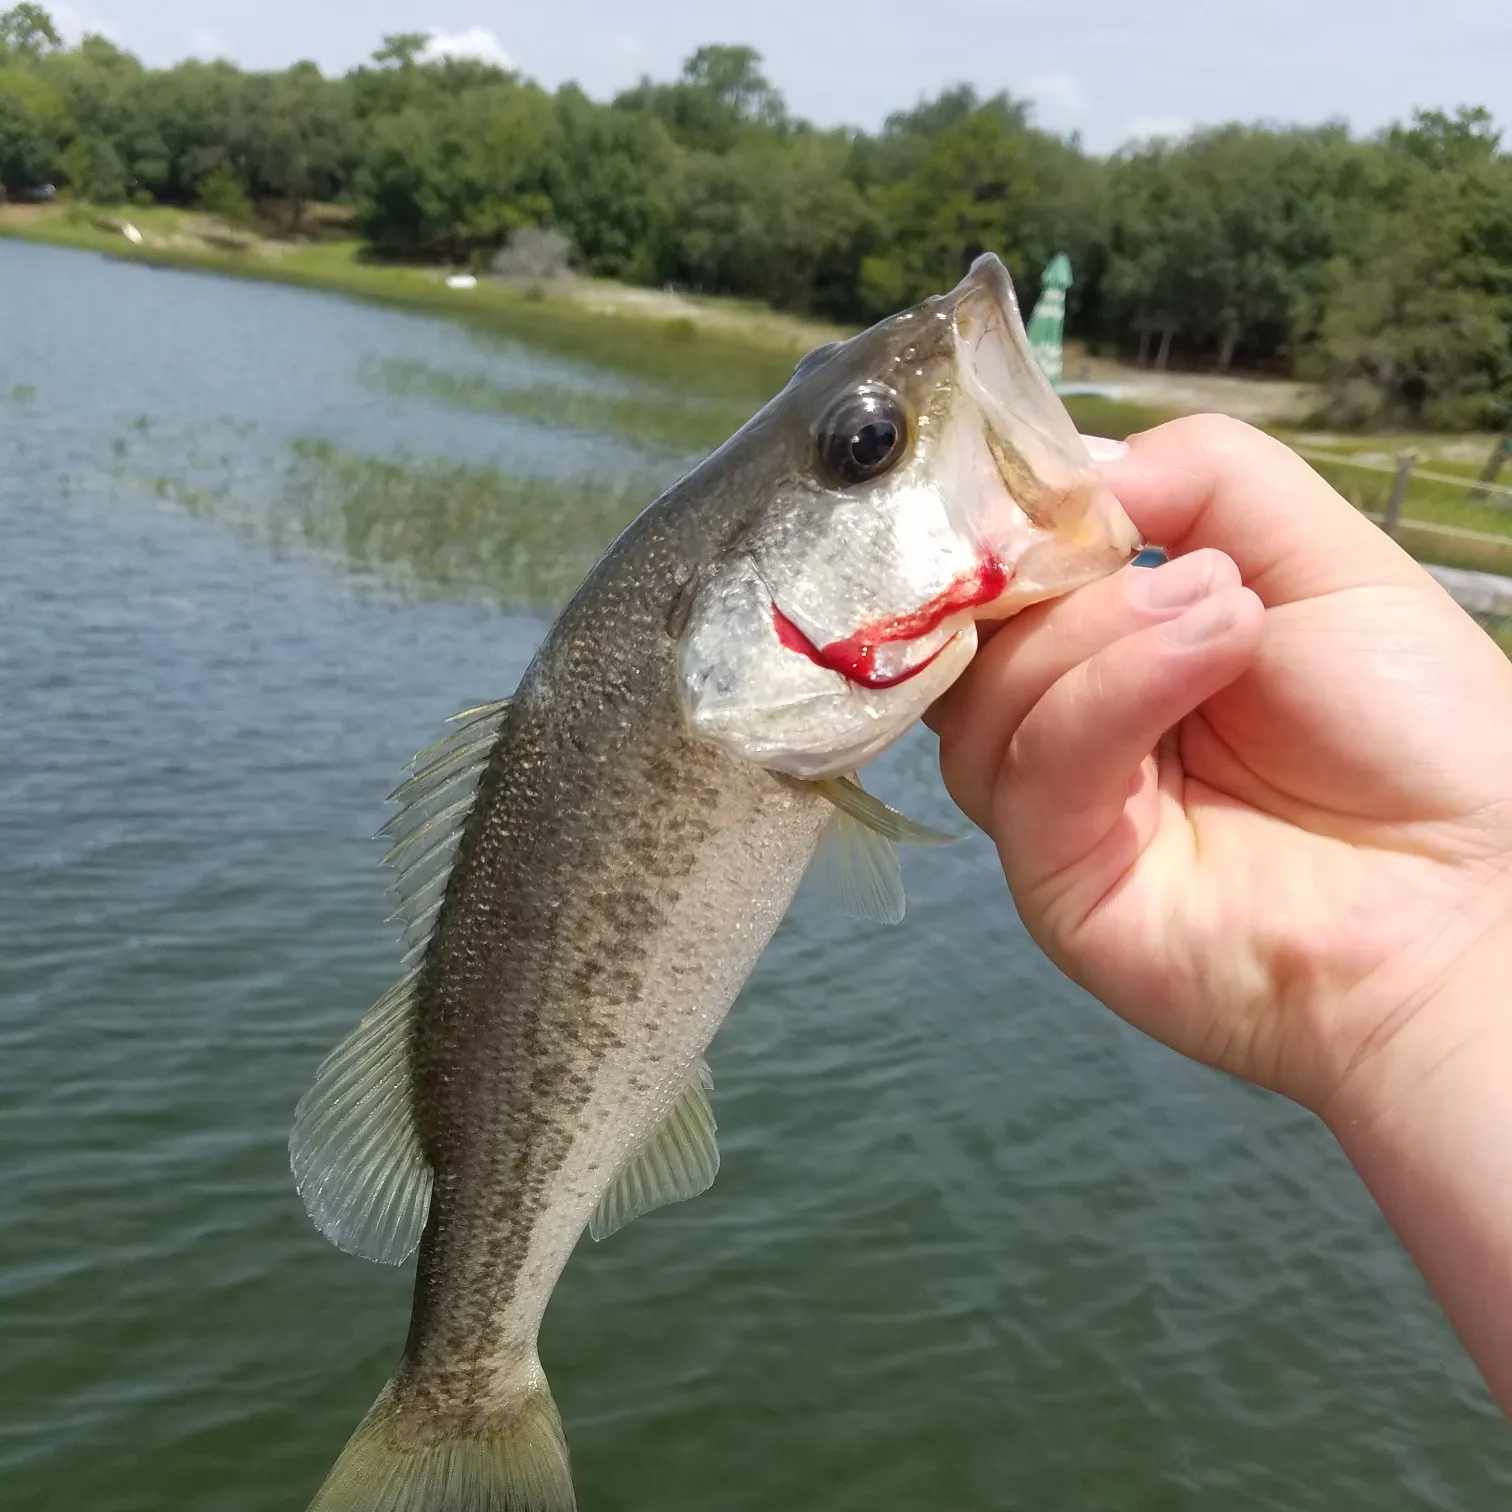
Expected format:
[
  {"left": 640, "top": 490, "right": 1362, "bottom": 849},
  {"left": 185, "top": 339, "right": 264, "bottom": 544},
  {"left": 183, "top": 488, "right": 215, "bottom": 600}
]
[{"left": 680, "top": 253, "right": 1142, "bottom": 779}]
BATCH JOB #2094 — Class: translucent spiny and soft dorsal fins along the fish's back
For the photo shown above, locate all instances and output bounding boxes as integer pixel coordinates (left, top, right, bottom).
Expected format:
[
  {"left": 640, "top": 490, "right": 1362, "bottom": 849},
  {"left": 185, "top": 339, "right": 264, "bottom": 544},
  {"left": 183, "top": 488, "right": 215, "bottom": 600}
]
[{"left": 289, "top": 700, "right": 508, "bottom": 1266}]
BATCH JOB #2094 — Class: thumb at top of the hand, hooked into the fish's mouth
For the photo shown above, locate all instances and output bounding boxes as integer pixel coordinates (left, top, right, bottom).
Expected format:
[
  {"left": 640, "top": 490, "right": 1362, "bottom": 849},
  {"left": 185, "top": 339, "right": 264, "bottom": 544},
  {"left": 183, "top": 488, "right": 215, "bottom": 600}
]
[{"left": 1102, "top": 414, "right": 1433, "bottom": 605}]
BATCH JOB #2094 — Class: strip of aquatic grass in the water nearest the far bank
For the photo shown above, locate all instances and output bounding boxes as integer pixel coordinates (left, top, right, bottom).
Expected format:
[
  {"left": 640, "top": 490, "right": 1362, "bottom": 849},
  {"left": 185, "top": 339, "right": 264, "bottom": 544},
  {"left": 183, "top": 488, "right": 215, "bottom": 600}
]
[{"left": 360, "top": 360, "right": 756, "bottom": 452}]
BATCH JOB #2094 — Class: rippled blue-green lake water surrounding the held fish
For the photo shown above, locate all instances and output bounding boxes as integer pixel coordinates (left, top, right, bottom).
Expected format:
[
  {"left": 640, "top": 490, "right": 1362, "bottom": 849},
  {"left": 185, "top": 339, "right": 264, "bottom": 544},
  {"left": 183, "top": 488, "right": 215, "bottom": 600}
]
[{"left": 0, "top": 242, "right": 1512, "bottom": 1512}]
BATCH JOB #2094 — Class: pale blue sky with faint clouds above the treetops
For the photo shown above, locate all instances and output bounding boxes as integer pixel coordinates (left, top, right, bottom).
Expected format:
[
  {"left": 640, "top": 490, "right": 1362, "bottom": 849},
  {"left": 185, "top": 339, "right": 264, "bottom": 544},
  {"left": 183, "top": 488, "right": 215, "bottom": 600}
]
[{"left": 41, "top": 0, "right": 1512, "bottom": 153}]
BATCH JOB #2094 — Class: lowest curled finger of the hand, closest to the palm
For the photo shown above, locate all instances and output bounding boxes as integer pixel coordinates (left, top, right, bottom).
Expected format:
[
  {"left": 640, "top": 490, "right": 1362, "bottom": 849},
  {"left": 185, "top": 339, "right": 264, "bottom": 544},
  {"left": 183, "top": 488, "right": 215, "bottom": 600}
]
[{"left": 993, "top": 587, "right": 1266, "bottom": 922}]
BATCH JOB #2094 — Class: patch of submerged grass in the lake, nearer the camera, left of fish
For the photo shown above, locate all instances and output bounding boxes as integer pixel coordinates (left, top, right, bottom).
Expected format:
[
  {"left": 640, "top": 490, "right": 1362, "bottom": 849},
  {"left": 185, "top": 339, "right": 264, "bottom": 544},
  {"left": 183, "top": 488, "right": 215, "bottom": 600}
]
[{"left": 274, "top": 440, "right": 667, "bottom": 609}]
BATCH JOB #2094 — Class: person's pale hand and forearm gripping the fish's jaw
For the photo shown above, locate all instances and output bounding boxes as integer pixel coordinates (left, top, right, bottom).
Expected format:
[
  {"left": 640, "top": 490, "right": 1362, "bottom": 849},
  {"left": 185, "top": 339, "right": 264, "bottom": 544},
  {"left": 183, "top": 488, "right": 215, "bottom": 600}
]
[{"left": 930, "top": 416, "right": 1512, "bottom": 1414}]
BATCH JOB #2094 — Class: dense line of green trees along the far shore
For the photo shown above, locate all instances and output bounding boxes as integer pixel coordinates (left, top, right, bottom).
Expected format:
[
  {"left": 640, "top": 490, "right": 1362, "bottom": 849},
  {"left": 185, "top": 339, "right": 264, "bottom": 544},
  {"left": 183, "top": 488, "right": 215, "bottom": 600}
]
[{"left": 0, "top": 5, "right": 1512, "bottom": 428}]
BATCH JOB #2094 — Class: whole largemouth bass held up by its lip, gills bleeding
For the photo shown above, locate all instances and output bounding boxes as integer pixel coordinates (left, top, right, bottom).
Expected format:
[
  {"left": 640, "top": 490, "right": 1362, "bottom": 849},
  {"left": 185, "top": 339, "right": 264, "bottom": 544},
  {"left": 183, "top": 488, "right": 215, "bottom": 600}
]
[{"left": 289, "top": 254, "right": 1142, "bottom": 1512}]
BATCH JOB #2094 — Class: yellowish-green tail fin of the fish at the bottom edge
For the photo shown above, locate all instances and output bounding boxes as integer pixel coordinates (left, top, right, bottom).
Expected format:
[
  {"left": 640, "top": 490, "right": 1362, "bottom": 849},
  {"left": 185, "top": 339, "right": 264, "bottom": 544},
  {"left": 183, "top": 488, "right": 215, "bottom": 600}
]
[{"left": 310, "top": 1380, "right": 578, "bottom": 1512}]
